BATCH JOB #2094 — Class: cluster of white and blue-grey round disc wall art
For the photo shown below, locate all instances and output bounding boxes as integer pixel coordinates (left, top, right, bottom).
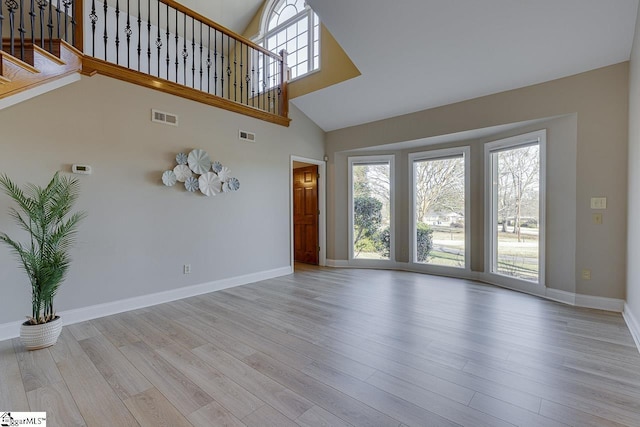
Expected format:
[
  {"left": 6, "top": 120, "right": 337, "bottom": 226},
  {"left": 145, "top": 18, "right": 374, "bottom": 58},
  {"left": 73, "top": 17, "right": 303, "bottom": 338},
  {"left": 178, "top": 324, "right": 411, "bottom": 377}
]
[{"left": 162, "top": 149, "right": 240, "bottom": 196}]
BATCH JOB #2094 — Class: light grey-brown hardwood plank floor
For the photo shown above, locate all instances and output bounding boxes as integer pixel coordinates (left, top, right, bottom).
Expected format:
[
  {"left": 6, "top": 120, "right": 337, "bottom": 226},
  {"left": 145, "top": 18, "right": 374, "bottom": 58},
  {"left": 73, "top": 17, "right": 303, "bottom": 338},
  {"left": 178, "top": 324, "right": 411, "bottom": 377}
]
[{"left": 0, "top": 265, "right": 640, "bottom": 427}]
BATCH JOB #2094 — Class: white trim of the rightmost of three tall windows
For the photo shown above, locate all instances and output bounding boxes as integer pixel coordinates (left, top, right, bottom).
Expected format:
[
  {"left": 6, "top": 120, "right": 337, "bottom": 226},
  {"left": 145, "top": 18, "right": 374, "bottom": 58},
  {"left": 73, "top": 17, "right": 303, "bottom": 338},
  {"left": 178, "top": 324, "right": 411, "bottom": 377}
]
[{"left": 484, "top": 129, "right": 547, "bottom": 287}]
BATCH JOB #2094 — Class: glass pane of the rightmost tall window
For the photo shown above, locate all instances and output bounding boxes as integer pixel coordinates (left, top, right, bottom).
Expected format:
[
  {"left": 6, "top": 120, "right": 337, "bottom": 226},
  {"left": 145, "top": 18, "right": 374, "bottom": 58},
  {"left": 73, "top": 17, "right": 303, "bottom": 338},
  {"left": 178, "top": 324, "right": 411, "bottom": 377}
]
[{"left": 492, "top": 144, "right": 540, "bottom": 282}]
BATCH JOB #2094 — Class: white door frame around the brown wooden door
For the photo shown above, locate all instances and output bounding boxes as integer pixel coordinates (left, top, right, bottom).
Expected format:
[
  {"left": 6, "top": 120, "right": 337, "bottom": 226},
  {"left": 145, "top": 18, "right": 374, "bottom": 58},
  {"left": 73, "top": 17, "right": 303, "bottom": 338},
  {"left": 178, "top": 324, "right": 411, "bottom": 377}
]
[{"left": 289, "top": 155, "right": 327, "bottom": 270}]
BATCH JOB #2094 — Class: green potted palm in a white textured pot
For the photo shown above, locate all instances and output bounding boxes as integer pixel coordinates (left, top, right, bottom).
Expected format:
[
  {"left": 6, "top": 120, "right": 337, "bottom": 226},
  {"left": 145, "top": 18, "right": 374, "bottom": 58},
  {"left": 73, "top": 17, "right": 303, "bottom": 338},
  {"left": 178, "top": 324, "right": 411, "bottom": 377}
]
[{"left": 0, "top": 172, "right": 86, "bottom": 350}]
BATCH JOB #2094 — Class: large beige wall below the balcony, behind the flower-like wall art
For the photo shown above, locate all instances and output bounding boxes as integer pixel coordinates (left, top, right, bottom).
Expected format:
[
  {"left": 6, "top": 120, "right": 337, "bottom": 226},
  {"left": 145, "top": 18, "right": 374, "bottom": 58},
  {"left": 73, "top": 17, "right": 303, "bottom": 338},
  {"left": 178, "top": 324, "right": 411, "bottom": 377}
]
[{"left": 0, "top": 76, "right": 324, "bottom": 324}]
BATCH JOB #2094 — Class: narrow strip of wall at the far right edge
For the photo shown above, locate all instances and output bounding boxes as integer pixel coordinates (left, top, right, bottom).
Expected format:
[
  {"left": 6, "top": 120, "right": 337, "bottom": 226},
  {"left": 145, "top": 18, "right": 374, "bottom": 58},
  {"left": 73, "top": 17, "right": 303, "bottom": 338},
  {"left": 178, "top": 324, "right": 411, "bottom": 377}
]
[{"left": 627, "top": 6, "right": 640, "bottom": 320}]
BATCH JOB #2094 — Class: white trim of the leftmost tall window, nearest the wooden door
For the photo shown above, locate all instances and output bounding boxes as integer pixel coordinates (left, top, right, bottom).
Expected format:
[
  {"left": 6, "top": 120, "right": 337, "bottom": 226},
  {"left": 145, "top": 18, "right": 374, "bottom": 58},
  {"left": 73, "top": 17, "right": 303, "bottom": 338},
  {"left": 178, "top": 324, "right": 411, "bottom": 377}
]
[{"left": 348, "top": 155, "right": 396, "bottom": 264}]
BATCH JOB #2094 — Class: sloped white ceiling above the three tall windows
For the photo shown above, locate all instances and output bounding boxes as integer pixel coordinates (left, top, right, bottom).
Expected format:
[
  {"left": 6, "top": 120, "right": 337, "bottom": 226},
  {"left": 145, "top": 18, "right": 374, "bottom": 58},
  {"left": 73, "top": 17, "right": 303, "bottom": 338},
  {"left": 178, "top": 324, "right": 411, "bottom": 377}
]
[{"left": 292, "top": 0, "right": 638, "bottom": 131}]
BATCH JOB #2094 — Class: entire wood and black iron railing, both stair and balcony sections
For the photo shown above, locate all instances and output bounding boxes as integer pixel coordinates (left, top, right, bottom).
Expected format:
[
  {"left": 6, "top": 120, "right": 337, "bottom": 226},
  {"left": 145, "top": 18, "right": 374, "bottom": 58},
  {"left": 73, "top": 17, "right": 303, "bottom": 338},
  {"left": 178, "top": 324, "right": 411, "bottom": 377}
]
[{"left": 0, "top": 0, "right": 289, "bottom": 126}]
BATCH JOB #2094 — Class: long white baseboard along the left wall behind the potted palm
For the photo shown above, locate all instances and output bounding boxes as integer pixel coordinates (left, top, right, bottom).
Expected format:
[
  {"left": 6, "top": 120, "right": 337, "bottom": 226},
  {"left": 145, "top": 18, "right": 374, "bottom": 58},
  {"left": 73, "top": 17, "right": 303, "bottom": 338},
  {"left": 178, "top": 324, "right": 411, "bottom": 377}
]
[{"left": 0, "top": 266, "right": 293, "bottom": 341}]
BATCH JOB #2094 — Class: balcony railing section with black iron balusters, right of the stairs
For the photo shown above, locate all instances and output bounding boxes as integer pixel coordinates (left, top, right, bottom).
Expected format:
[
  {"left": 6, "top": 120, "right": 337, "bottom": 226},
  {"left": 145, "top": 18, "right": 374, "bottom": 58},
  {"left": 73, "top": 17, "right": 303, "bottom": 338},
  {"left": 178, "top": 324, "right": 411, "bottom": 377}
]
[{"left": 84, "top": 0, "right": 289, "bottom": 124}]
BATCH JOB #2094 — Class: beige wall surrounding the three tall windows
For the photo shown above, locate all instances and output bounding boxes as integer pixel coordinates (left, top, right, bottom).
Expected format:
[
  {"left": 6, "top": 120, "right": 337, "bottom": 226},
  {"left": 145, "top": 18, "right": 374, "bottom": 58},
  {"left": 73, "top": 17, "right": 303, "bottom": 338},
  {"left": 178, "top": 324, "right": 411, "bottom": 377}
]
[{"left": 327, "top": 63, "right": 628, "bottom": 298}]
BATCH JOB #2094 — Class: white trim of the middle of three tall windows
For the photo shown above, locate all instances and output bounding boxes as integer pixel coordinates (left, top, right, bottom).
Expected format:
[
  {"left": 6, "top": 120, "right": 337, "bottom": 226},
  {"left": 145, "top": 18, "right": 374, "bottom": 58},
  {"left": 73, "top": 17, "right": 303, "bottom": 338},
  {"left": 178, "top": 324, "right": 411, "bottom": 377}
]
[{"left": 408, "top": 146, "right": 471, "bottom": 272}]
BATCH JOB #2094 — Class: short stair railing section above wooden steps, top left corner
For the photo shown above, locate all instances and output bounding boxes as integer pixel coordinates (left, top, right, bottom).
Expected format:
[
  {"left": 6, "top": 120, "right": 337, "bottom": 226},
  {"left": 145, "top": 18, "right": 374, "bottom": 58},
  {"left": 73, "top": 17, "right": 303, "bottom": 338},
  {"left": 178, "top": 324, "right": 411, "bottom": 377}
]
[{"left": 0, "top": 0, "right": 83, "bottom": 61}]
